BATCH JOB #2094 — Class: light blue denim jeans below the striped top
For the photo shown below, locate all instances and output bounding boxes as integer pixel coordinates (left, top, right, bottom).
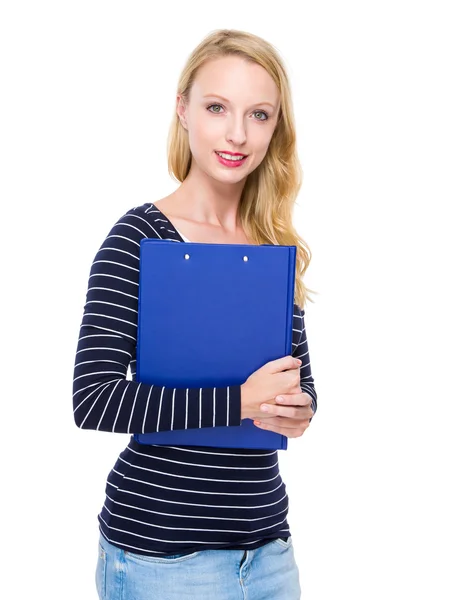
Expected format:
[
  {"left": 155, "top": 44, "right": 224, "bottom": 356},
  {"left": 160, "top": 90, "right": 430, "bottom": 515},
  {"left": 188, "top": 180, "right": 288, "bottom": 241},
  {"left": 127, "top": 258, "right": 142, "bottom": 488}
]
[{"left": 95, "top": 534, "right": 300, "bottom": 600}]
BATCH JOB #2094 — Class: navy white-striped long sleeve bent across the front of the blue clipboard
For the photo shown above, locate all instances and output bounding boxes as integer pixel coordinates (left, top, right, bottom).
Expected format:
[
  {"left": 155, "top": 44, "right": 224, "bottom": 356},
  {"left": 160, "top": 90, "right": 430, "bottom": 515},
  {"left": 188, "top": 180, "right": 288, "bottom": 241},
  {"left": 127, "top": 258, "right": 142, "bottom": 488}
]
[{"left": 73, "top": 207, "right": 241, "bottom": 433}]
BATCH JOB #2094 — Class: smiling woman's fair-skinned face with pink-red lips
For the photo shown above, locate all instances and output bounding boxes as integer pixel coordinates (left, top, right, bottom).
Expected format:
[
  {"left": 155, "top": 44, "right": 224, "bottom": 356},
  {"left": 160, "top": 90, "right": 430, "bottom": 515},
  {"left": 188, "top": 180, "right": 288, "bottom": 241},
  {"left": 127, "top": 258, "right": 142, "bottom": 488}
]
[{"left": 177, "top": 56, "right": 280, "bottom": 183}]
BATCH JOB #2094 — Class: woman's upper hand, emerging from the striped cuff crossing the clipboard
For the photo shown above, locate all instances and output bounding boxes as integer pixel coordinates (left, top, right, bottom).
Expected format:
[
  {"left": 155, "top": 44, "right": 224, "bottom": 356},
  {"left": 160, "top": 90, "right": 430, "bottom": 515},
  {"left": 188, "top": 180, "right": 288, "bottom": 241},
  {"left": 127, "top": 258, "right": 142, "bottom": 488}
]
[{"left": 241, "top": 356, "right": 302, "bottom": 420}]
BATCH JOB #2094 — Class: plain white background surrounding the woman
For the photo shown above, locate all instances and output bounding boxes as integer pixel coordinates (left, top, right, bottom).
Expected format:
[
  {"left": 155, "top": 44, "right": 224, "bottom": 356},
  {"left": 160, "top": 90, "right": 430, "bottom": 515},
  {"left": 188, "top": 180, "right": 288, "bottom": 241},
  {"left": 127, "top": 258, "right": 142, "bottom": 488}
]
[{"left": 0, "top": 0, "right": 467, "bottom": 600}]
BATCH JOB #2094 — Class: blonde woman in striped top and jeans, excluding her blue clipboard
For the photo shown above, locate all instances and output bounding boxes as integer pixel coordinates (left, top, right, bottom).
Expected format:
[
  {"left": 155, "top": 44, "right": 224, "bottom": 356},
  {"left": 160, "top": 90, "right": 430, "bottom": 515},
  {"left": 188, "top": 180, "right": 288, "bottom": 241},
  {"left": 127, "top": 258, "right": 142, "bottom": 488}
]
[{"left": 73, "top": 25, "right": 316, "bottom": 600}]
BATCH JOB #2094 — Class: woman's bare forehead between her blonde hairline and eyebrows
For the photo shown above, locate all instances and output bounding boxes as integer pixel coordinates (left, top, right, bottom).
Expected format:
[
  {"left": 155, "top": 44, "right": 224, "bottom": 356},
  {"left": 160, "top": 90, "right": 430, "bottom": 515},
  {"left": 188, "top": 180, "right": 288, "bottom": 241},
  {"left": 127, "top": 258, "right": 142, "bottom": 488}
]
[{"left": 192, "top": 56, "right": 279, "bottom": 104}]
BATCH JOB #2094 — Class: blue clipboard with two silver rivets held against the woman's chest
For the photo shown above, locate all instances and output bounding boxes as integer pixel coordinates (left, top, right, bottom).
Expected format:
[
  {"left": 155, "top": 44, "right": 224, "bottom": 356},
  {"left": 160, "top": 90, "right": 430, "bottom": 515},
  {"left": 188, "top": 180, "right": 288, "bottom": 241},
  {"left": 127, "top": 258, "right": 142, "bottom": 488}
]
[{"left": 134, "top": 238, "right": 296, "bottom": 450}]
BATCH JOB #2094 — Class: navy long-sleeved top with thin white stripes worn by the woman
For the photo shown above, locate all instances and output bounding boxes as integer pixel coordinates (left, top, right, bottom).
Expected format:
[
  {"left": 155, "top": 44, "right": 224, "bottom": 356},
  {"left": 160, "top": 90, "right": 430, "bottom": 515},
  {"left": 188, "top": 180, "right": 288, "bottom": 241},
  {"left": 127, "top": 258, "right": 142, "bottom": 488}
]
[{"left": 73, "top": 202, "right": 317, "bottom": 556}]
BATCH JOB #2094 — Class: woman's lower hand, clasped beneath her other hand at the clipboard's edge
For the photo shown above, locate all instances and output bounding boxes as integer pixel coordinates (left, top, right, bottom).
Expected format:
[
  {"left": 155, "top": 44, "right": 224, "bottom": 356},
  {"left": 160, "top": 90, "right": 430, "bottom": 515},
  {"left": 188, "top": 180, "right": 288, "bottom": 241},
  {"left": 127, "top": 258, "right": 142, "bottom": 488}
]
[{"left": 254, "top": 388, "right": 314, "bottom": 438}]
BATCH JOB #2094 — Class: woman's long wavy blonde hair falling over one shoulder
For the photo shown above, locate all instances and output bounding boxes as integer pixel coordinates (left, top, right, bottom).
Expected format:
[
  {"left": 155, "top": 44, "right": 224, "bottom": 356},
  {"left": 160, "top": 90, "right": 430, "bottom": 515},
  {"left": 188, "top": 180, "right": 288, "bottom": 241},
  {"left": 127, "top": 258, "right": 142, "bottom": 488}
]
[{"left": 167, "top": 29, "right": 316, "bottom": 309}]
